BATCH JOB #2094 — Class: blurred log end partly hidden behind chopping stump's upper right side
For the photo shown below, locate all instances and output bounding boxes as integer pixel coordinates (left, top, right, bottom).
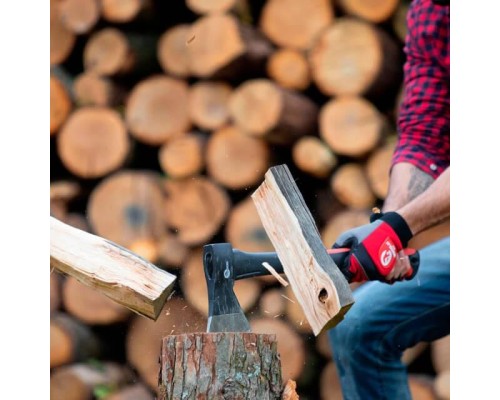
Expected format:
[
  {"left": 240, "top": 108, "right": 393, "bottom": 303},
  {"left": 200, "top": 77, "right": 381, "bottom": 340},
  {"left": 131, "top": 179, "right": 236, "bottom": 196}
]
[{"left": 249, "top": 317, "right": 306, "bottom": 380}]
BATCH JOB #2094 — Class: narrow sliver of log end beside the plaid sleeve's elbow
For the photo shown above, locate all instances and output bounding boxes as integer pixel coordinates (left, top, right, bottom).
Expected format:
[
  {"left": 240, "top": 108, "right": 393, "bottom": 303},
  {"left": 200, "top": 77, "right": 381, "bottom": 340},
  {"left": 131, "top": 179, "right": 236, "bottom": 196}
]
[{"left": 365, "top": 136, "right": 396, "bottom": 200}]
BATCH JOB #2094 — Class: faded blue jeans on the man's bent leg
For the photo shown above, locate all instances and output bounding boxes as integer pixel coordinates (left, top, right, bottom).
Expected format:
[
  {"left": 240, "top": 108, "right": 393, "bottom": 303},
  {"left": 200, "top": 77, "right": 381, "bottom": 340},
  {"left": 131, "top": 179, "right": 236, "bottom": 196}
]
[{"left": 328, "top": 237, "right": 450, "bottom": 400}]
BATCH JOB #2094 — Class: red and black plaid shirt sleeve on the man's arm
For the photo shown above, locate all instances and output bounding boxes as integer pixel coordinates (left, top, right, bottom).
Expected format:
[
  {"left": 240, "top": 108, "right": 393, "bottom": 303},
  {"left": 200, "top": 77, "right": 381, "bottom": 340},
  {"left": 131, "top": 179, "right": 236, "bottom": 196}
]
[{"left": 392, "top": 0, "right": 450, "bottom": 178}]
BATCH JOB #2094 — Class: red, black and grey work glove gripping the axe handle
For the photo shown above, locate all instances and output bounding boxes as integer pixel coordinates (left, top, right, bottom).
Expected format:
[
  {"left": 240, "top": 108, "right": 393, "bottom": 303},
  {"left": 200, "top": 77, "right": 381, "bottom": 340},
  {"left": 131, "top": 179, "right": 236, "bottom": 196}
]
[{"left": 332, "top": 211, "right": 420, "bottom": 283}]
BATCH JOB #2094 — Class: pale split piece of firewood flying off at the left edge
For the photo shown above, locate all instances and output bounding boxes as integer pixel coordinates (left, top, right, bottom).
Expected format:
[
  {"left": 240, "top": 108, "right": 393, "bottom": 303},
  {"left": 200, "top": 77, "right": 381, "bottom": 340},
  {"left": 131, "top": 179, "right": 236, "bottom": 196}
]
[{"left": 50, "top": 216, "right": 176, "bottom": 320}]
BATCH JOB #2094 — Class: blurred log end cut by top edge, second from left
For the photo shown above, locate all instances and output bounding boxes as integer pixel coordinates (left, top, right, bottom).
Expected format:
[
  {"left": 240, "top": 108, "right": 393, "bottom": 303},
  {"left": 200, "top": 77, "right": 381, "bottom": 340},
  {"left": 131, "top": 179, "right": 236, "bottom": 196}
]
[{"left": 101, "top": 0, "right": 153, "bottom": 24}]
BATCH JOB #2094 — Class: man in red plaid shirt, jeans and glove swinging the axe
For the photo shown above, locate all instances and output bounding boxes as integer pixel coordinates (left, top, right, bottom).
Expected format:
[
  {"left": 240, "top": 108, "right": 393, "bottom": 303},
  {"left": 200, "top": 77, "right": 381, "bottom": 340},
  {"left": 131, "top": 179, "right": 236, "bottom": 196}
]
[{"left": 329, "top": 0, "right": 450, "bottom": 400}]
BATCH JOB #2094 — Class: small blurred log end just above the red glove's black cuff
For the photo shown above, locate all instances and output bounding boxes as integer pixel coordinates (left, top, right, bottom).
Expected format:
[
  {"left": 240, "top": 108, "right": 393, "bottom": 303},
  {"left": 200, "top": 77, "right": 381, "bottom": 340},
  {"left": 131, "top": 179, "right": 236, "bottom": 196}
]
[{"left": 330, "top": 162, "right": 376, "bottom": 209}]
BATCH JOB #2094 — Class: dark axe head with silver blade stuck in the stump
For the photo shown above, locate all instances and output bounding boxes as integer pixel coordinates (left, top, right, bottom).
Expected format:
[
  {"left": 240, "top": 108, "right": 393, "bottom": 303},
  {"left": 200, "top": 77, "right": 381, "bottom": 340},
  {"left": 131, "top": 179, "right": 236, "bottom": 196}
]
[{"left": 203, "top": 243, "right": 250, "bottom": 332}]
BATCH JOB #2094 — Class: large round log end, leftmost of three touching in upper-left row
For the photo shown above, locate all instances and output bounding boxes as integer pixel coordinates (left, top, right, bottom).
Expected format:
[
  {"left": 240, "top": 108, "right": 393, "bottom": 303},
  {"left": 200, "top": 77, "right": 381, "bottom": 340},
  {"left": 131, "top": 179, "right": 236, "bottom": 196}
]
[{"left": 125, "top": 75, "right": 191, "bottom": 146}]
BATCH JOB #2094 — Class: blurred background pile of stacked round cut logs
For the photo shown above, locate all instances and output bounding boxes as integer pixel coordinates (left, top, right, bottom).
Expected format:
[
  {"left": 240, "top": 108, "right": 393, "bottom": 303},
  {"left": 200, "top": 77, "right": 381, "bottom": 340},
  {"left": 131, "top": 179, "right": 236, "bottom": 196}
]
[{"left": 50, "top": 0, "right": 449, "bottom": 400}]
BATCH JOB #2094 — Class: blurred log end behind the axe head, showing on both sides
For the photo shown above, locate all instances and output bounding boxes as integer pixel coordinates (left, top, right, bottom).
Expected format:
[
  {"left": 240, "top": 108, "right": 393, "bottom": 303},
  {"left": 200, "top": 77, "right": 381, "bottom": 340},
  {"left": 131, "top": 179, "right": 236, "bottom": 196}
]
[{"left": 180, "top": 248, "right": 261, "bottom": 317}]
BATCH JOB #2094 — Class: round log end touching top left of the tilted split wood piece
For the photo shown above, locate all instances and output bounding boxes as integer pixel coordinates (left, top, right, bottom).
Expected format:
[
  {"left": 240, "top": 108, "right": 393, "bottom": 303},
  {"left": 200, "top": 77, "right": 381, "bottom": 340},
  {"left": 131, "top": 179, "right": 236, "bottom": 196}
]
[{"left": 206, "top": 125, "right": 270, "bottom": 190}]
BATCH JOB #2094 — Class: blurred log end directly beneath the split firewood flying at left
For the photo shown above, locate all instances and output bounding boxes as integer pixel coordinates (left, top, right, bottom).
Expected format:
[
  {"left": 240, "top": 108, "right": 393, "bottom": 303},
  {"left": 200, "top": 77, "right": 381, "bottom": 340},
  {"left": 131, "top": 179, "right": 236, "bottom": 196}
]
[{"left": 62, "top": 276, "right": 132, "bottom": 325}]
